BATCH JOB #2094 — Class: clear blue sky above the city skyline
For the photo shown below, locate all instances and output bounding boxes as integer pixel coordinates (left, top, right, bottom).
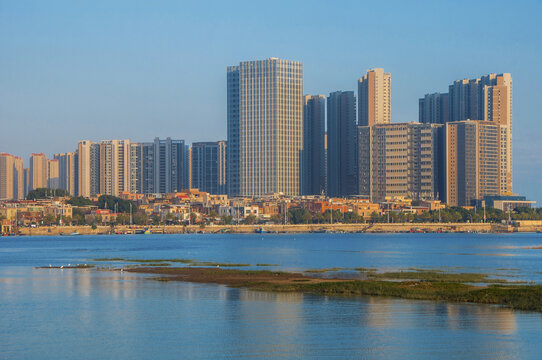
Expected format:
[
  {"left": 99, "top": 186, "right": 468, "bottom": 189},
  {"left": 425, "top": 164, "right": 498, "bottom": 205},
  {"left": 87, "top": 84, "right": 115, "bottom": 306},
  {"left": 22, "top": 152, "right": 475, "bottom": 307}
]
[{"left": 0, "top": 0, "right": 542, "bottom": 202}]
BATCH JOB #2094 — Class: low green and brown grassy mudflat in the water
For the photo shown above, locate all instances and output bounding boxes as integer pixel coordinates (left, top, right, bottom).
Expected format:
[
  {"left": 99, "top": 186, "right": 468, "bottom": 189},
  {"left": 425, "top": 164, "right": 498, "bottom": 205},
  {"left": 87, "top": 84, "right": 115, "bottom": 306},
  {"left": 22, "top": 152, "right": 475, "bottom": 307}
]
[{"left": 123, "top": 266, "right": 542, "bottom": 312}]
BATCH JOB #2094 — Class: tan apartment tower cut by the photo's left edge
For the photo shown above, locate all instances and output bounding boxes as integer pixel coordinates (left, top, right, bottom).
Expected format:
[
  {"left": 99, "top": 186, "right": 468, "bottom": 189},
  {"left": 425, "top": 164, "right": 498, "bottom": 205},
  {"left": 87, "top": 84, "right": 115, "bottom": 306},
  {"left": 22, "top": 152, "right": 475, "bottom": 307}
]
[{"left": 0, "top": 153, "right": 24, "bottom": 200}]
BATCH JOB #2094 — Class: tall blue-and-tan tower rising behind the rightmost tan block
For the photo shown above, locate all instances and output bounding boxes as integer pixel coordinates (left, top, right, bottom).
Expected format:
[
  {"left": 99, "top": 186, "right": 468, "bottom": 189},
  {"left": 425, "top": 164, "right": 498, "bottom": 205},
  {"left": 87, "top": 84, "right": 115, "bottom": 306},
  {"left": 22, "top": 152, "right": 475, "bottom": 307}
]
[{"left": 449, "top": 73, "right": 513, "bottom": 194}]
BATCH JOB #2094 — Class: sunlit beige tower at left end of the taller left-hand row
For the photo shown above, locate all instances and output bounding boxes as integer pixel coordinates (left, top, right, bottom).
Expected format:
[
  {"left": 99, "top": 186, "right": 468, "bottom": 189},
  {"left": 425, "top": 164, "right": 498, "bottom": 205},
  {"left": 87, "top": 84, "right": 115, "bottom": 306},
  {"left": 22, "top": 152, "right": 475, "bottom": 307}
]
[{"left": 77, "top": 140, "right": 100, "bottom": 197}]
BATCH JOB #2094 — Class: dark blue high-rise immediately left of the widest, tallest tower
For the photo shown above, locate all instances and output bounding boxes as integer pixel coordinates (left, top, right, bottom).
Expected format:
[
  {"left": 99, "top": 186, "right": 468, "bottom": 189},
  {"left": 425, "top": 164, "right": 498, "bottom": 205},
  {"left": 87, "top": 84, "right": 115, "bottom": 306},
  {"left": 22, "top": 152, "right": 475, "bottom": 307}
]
[{"left": 191, "top": 141, "right": 226, "bottom": 194}]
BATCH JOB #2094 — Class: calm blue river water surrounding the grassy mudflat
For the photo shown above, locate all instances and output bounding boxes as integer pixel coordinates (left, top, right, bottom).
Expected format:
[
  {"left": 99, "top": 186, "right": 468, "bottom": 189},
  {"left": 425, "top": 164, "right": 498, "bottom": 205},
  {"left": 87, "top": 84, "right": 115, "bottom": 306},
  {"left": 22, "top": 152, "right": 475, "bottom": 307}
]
[{"left": 0, "top": 234, "right": 542, "bottom": 359}]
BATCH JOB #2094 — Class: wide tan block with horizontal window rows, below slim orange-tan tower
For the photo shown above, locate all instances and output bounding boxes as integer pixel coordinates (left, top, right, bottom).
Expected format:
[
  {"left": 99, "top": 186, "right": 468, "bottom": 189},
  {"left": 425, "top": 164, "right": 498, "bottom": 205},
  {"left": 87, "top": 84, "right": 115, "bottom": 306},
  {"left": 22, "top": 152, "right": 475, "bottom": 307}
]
[{"left": 358, "top": 123, "right": 443, "bottom": 202}]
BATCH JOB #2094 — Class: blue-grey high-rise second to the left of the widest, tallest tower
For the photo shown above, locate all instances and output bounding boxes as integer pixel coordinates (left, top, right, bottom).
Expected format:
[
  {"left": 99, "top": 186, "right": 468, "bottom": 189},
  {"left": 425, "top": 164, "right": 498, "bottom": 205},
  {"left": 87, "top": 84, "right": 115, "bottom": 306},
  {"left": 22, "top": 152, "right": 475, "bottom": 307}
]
[{"left": 154, "top": 137, "right": 188, "bottom": 194}]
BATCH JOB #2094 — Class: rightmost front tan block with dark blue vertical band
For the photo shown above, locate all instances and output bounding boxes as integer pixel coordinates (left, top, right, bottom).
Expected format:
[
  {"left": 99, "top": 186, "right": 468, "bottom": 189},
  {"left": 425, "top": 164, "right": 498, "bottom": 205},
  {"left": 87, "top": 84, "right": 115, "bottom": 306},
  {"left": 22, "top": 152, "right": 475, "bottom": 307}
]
[{"left": 443, "top": 120, "right": 502, "bottom": 206}]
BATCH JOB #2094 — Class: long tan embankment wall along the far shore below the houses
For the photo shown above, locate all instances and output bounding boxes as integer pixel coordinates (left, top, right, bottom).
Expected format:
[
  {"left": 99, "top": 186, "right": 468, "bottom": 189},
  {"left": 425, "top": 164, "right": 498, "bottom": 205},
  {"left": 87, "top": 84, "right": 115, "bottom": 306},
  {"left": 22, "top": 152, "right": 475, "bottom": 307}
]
[{"left": 14, "top": 221, "right": 542, "bottom": 236}]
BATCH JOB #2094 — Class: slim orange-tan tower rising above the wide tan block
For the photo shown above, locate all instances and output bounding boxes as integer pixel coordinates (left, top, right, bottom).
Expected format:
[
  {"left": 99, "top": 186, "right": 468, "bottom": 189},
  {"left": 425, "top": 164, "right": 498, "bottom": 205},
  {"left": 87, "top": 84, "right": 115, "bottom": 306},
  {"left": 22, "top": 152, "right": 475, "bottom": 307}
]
[{"left": 358, "top": 69, "right": 391, "bottom": 126}]
